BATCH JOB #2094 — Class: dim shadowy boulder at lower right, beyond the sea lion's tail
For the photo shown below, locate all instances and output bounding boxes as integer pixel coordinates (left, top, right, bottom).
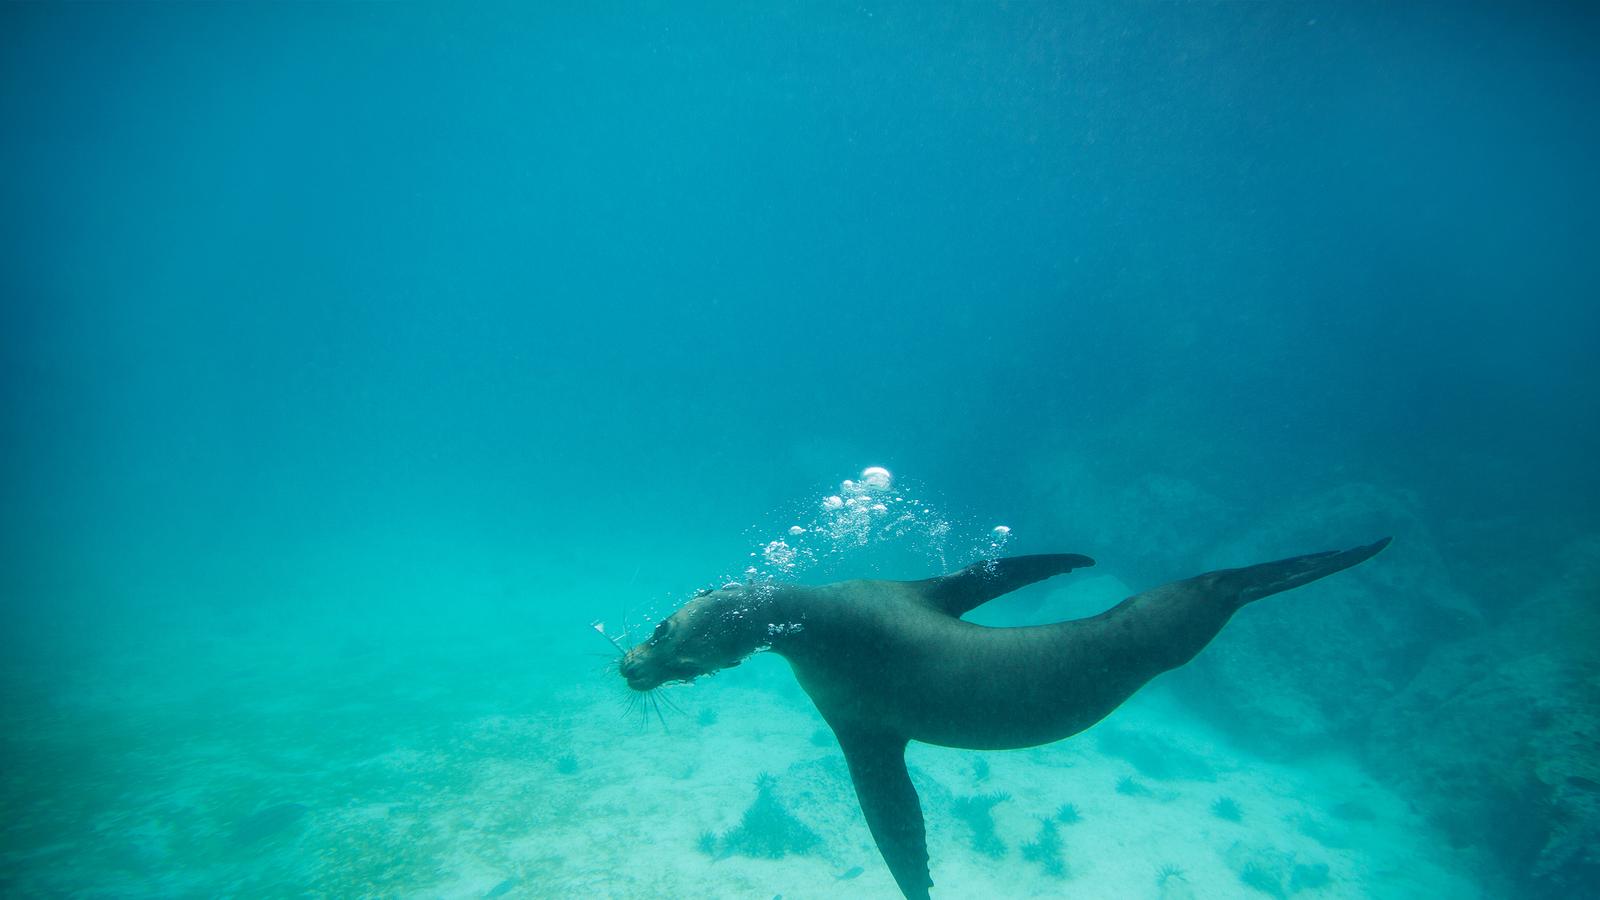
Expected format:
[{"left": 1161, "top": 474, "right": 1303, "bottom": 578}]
[{"left": 1366, "top": 538, "right": 1600, "bottom": 897}]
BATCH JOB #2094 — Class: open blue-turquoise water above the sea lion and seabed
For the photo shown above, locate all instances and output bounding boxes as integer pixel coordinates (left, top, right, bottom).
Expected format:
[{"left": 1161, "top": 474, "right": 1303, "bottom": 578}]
[{"left": 0, "top": 3, "right": 1600, "bottom": 895}]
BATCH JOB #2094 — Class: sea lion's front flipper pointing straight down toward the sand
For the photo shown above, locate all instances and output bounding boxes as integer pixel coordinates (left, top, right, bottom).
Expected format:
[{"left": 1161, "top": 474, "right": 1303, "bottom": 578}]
[{"left": 834, "top": 729, "right": 933, "bottom": 900}]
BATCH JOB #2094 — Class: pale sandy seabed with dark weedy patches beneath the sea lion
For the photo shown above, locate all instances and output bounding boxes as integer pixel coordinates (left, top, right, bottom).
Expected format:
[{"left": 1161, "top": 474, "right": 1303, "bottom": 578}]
[{"left": 0, "top": 624, "right": 1482, "bottom": 900}]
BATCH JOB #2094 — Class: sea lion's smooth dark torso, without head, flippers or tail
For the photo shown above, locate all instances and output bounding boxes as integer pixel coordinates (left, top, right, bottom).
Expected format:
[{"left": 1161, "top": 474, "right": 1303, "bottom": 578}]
[{"left": 778, "top": 581, "right": 1203, "bottom": 749}]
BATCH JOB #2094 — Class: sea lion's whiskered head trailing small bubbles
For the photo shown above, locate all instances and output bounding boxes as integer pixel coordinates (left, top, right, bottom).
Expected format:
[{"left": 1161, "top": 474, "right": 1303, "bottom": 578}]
[{"left": 618, "top": 585, "right": 770, "bottom": 690}]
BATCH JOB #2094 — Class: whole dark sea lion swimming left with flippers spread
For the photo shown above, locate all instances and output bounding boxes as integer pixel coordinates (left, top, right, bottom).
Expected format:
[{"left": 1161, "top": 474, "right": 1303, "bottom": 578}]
[{"left": 618, "top": 538, "right": 1389, "bottom": 900}]
